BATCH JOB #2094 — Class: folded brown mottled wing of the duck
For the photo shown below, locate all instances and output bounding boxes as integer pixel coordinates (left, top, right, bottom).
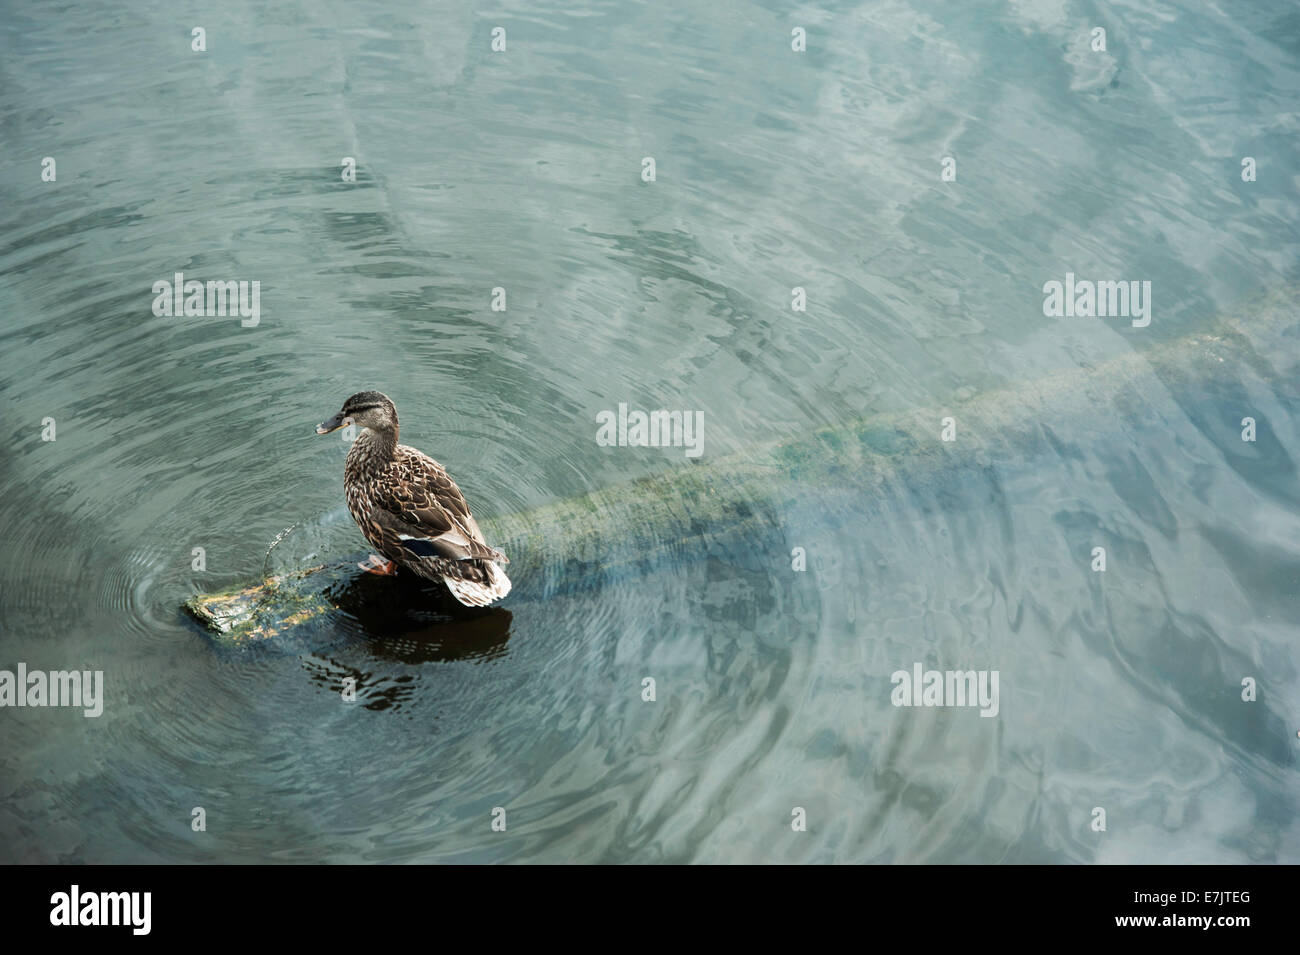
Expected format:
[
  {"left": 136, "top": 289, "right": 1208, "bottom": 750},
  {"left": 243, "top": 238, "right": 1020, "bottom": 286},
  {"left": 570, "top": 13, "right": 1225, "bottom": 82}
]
[{"left": 371, "top": 450, "right": 508, "bottom": 564}]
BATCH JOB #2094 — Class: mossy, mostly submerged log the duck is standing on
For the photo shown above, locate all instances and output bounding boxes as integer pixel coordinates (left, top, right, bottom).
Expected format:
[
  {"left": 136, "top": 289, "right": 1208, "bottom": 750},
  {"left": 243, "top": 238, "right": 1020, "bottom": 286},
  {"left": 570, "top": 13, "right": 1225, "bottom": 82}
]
[{"left": 185, "top": 288, "right": 1300, "bottom": 650}]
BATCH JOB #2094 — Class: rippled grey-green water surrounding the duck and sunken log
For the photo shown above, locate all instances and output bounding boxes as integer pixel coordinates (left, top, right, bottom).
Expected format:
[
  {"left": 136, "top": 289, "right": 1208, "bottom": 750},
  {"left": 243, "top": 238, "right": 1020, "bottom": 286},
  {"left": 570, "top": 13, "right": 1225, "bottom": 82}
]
[{"left": 0, "top": 1, "right": 1300, "bottom": 863}]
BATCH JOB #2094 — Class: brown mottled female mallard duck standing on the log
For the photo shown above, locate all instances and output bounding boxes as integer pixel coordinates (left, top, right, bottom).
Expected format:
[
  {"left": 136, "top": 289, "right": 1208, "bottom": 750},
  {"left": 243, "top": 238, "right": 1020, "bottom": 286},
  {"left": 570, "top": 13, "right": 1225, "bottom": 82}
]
[{"left": 316, "top": 391, "right": 510, "bottom": 607}]
